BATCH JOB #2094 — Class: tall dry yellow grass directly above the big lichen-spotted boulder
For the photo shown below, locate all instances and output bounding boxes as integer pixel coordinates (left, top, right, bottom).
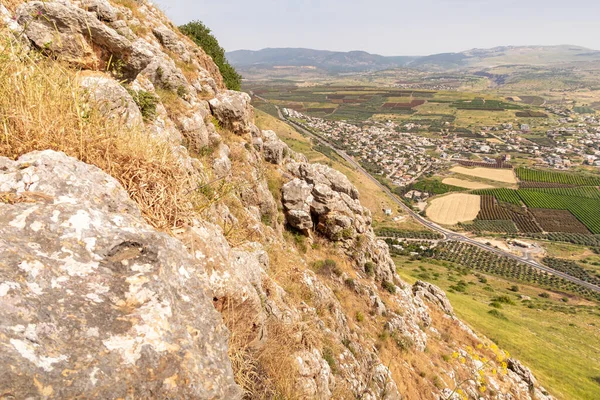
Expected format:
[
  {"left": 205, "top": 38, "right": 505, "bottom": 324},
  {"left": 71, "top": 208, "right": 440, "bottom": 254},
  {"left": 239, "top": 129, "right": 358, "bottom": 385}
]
[{"left": 0, "top": 38, "right": 192, "bottom": 230}]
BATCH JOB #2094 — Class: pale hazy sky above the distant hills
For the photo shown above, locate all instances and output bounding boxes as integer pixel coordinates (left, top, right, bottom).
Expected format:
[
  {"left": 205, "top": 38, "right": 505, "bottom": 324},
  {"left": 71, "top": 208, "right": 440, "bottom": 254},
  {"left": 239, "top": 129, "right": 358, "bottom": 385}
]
[{"left": 154, "top": 0, "right": 600, "bottom": 55}]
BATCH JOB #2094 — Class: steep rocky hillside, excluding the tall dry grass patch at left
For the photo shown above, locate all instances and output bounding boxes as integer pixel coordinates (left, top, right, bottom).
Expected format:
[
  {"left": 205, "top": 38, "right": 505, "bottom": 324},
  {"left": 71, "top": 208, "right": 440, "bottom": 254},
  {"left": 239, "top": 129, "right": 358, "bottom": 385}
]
[{"left": 0, "top": 0, "right": 550, "bottom": 399}]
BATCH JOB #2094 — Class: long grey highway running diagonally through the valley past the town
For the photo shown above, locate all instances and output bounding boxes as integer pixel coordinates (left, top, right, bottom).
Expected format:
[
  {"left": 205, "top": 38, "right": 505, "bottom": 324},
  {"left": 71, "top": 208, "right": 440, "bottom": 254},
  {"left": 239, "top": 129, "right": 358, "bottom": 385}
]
[{"left": 270, "top": 103, "right": 600, "bottom": 292}]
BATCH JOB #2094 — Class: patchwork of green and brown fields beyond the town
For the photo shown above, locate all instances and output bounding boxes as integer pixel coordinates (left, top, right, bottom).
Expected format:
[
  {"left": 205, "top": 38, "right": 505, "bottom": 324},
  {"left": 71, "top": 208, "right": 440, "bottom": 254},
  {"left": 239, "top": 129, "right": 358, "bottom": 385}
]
[{"left": 243, "top": 83, "right": 542, "bottom": 134}]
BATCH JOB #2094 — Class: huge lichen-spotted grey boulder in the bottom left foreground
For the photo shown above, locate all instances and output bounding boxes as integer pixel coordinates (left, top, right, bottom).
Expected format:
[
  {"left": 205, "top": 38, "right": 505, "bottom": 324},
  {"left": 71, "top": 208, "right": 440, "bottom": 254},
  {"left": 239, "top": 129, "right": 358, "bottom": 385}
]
[{"left": 0, "top": 151, "right": 240, "bottom": 399}]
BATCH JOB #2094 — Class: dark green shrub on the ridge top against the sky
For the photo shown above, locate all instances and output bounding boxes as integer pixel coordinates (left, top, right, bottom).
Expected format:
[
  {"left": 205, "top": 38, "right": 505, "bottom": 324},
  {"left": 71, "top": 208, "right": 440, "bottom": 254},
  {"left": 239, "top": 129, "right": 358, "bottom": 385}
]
[{"left": 179, "top": 21, "right": 242, "bottom": 90}]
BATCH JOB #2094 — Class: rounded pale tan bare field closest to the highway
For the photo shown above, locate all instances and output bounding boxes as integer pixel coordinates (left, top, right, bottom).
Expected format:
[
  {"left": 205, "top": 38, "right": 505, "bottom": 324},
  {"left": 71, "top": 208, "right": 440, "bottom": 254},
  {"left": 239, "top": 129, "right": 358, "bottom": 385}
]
[{"left": 426, "top": 193, "right": 481, "bottom": 225}]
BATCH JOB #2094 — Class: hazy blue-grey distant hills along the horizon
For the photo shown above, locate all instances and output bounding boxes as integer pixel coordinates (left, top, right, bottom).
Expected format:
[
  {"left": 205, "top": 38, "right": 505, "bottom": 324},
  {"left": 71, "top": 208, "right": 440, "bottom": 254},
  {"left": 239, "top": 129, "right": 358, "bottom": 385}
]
[{"left": 227, "top": 45, "right": 600, "bottom": 72}]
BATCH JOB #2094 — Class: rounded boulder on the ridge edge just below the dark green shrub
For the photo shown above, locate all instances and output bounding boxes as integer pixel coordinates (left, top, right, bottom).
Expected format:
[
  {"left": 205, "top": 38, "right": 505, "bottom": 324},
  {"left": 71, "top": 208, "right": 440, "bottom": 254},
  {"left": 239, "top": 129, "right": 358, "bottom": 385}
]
[{"left": 209, "top": 90, "right": 254, "bottom": 135}]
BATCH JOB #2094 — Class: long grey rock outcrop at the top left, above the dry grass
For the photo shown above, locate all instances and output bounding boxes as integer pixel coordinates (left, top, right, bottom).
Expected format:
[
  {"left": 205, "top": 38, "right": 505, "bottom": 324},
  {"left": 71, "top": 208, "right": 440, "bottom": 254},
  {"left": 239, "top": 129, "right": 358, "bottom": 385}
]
[{"left": 17, "top": 1, "right": 153, "bottom": 78}]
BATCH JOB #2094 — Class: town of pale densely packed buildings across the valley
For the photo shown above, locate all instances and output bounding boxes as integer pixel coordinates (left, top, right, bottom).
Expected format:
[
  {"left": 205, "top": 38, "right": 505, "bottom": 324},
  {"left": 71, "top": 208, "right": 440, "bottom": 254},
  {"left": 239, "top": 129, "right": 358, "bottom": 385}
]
[{"left": 284, "top": 109, "right": 600, "bottom": 181}]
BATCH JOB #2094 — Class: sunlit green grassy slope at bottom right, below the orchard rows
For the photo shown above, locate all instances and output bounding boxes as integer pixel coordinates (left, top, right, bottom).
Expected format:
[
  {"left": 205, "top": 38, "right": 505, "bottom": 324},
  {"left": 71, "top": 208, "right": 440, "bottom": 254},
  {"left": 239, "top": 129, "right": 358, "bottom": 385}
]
[{"left": 396, "top": 257, "right": 600, "bottom": 400}]
